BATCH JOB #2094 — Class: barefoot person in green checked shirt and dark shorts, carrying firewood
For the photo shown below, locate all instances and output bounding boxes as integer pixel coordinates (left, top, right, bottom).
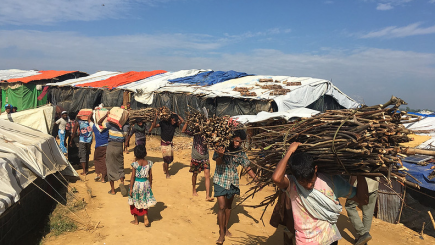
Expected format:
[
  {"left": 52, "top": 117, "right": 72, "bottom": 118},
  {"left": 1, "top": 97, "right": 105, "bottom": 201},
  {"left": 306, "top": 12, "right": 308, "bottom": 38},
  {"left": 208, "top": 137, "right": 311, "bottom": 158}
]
[{"left": 213, "top": 130, "right": 255, "bottom": 244}]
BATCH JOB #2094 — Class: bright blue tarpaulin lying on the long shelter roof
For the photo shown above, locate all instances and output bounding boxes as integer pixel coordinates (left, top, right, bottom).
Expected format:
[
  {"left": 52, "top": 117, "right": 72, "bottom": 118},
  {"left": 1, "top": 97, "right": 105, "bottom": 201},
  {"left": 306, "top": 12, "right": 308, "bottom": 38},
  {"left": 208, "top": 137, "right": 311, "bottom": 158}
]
[{"left": 169, "top": 71, "right": 252, "bottom": 86}]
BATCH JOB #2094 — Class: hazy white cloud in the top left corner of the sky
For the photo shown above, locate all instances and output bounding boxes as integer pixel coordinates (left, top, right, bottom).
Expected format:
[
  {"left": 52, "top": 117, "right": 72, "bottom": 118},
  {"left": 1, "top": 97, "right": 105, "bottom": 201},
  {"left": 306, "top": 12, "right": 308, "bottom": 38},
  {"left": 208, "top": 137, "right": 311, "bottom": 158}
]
[{"left": 0, "top": 0, "right": 170, "bottom": 25}]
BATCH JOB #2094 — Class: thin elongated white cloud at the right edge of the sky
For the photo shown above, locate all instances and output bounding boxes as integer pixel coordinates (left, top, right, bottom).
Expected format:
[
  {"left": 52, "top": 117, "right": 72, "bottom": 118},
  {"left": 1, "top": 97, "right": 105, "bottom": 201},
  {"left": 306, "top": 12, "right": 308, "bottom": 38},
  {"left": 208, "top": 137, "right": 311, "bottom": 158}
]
[{"left": 361, "top": 22, "right": 435, "bottom": 38}]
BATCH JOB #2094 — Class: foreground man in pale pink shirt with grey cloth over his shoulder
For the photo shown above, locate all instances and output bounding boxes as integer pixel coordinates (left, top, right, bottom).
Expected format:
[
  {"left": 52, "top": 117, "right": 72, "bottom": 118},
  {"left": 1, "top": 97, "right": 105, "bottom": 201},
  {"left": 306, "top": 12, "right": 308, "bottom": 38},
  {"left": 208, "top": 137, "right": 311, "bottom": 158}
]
[{"left": 272, "top": 142, "right": 368, "bottom": 245}]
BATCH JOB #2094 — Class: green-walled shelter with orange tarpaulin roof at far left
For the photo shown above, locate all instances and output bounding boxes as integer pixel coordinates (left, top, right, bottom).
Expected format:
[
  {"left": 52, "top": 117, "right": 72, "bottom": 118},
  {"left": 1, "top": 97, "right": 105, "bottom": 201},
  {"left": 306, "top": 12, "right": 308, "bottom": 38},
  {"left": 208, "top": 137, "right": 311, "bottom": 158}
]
[{"left": 0, "top": 70, "right": 87, "bottom": 111}]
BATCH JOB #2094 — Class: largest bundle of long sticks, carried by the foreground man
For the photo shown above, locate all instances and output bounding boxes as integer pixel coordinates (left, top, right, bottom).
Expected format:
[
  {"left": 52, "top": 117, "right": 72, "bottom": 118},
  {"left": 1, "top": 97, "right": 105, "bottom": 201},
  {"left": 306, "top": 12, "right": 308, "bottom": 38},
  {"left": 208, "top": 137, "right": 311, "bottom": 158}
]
[{"left": 244, "top": 96, "right": 420, "bottom": 211}]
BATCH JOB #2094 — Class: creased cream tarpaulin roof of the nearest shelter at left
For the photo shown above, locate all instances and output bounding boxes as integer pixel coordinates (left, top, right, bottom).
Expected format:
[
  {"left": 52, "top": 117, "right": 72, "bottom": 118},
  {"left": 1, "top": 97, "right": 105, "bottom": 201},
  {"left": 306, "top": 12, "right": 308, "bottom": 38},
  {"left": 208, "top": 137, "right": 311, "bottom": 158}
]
[{"left": 0, "top": 120, "right": 78, "bottom": 214}]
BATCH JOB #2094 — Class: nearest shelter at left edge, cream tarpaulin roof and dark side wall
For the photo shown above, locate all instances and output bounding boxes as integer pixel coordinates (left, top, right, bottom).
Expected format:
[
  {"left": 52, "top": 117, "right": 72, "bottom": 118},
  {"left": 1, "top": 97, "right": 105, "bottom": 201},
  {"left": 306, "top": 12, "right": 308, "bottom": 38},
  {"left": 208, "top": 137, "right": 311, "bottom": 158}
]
[{"left": 0, "top": 120, "right": 78, "bottom": 244}]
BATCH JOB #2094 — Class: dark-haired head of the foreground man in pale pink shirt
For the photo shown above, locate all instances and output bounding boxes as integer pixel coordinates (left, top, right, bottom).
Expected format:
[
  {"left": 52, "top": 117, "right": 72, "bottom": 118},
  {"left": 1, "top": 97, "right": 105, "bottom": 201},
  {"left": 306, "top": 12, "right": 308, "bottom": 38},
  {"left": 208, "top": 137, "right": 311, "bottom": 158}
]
[{"left": 289, "top": 152, "right": 317, "bottom": 190}]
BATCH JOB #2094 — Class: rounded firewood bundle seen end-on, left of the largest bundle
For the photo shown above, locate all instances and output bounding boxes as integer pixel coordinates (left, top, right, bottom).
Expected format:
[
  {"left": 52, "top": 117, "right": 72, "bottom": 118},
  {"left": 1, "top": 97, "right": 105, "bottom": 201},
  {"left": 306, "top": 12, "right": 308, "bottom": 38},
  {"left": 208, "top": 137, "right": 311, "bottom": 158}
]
[{"left": 187, "top": 111, "right": 235, "bottom": 149}]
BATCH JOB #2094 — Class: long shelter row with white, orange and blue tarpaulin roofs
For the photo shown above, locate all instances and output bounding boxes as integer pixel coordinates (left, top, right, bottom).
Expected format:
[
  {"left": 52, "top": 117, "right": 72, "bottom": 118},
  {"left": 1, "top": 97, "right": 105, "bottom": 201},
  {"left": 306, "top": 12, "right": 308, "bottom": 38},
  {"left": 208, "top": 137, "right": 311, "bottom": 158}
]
[{"left": 0, "top": 69, "right": 358, "bottom": 119}]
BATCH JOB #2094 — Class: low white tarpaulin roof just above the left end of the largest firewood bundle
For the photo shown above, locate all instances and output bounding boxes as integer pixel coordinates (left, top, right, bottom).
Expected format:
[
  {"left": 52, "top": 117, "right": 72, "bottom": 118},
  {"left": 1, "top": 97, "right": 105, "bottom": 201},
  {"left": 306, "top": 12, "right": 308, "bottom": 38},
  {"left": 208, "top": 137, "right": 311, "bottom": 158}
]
[{"left": 232, "top": 108, "right": 320, "bottom": 123}]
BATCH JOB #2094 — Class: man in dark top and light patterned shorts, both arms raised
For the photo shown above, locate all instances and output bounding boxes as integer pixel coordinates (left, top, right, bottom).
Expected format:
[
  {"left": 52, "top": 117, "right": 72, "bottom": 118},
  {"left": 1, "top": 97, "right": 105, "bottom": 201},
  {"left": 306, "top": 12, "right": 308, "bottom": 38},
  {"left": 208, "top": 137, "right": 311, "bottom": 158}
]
[{"left": 148, "top": 112, "right": 184, "bottom": 179}]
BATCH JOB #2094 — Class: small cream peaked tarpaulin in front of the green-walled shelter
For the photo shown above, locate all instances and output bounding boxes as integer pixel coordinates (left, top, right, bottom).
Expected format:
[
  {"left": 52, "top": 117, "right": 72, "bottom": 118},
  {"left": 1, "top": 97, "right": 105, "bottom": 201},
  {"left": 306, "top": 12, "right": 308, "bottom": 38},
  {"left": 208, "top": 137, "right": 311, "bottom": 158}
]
[{"left": 0, "top": 105, "right": 55, "bottom": 134}]
